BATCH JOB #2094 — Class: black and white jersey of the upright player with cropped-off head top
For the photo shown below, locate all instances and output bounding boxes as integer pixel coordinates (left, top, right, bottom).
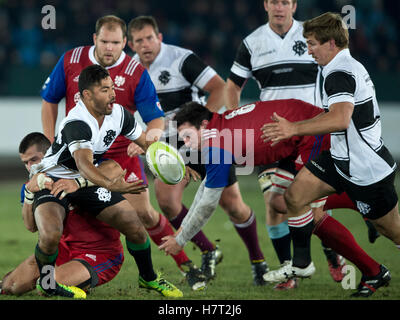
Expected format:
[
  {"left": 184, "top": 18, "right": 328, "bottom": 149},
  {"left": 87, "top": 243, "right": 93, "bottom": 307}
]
[{"left": 229, "top": 20, "right": 318, "bottom": 105}]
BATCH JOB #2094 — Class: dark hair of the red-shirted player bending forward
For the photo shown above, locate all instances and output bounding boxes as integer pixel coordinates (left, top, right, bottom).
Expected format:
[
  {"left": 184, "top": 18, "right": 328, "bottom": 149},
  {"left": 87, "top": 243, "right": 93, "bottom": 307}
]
[{"left": 174, "top": 101, "right": 213, "bottom": 129}]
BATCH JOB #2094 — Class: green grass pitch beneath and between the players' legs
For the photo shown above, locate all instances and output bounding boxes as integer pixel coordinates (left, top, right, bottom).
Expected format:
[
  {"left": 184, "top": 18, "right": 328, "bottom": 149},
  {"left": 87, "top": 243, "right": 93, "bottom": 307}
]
[{"left": 0, "top": 172, "right": 400, "bottom": 303}]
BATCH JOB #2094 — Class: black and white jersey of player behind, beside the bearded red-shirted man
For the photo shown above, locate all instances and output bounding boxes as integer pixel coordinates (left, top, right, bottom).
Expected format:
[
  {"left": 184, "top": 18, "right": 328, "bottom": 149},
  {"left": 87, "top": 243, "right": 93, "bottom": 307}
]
[{"left": 133, "top": 43, "right": 216, "bottom": 134}]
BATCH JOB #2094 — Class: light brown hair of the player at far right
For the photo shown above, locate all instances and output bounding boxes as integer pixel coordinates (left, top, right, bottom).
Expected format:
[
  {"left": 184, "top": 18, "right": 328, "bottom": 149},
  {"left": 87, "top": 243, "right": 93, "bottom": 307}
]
[{"left": 303, "top": 12, "right": 349, "bottom": 49}]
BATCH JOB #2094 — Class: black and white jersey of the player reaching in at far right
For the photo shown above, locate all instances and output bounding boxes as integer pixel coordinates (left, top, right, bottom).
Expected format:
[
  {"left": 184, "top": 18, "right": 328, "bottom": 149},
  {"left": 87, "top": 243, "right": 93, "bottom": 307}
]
[{"left": 322, "top": 49, "right": 396, "bottom": 186}]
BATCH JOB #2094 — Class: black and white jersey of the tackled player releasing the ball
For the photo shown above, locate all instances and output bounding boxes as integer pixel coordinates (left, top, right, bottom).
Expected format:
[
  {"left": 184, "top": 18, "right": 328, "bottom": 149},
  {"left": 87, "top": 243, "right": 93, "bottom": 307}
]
[{"left": 32, "top": 100, "right": 142, "bottom": 179}]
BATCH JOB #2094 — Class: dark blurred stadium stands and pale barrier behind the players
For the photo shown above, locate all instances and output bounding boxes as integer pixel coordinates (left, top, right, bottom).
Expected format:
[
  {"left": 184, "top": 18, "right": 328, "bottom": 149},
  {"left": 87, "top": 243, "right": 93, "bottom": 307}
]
[{"left": 0, "top": 0, "right": 400, "bottom": 299}]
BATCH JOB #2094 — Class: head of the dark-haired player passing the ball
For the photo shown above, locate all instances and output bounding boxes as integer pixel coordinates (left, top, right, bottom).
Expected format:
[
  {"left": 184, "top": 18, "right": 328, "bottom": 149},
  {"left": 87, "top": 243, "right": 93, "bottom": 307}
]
[{"left": 78, "top": 64, "right": 115, "bottom": 116}]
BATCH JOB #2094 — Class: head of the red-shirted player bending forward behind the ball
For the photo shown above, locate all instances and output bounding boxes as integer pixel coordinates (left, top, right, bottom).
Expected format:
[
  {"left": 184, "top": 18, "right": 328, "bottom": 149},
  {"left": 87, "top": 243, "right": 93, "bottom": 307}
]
[{"left": 174, "top": 102, "right": 213, "bottom": 149}]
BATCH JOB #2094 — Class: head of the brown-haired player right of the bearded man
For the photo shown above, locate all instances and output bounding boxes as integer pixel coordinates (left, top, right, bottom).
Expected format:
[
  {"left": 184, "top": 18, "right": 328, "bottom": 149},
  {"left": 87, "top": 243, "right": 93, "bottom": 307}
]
[{"left": 128, "top": 16, "right": 162, "bottom": 68}]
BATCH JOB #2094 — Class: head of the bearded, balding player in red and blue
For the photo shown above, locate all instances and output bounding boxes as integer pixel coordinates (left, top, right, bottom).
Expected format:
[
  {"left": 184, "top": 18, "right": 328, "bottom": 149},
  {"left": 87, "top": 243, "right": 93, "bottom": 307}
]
[{"left": 93, "top": 15, "right": 126, "bottom": 67}]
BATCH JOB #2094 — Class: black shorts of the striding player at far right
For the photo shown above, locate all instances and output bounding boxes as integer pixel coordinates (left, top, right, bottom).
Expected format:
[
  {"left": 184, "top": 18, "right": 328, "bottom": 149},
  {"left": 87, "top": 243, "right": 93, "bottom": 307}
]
[{"left": 306, "top": 150, "right": 398, "bottom": 220}]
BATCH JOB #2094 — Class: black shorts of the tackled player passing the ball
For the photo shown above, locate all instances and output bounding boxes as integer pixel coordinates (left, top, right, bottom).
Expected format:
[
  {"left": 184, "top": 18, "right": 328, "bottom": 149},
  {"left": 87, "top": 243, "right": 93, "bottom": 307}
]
[{"left": 33, "top": 186, "right": 125, "bottom": 216}]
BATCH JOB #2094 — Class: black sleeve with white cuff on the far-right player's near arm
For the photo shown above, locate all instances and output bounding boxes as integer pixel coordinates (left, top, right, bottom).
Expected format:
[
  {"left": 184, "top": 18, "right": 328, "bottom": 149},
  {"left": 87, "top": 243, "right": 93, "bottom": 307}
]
[{"left": 324, "top": 71, "right": 356, "bottom": 106}]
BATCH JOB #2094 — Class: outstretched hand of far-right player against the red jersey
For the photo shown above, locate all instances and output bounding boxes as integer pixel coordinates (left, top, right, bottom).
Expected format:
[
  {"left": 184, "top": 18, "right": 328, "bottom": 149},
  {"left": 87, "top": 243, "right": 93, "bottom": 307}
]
[{"left": 261, "top": 112, "right": 295, "bottom": 146}]
